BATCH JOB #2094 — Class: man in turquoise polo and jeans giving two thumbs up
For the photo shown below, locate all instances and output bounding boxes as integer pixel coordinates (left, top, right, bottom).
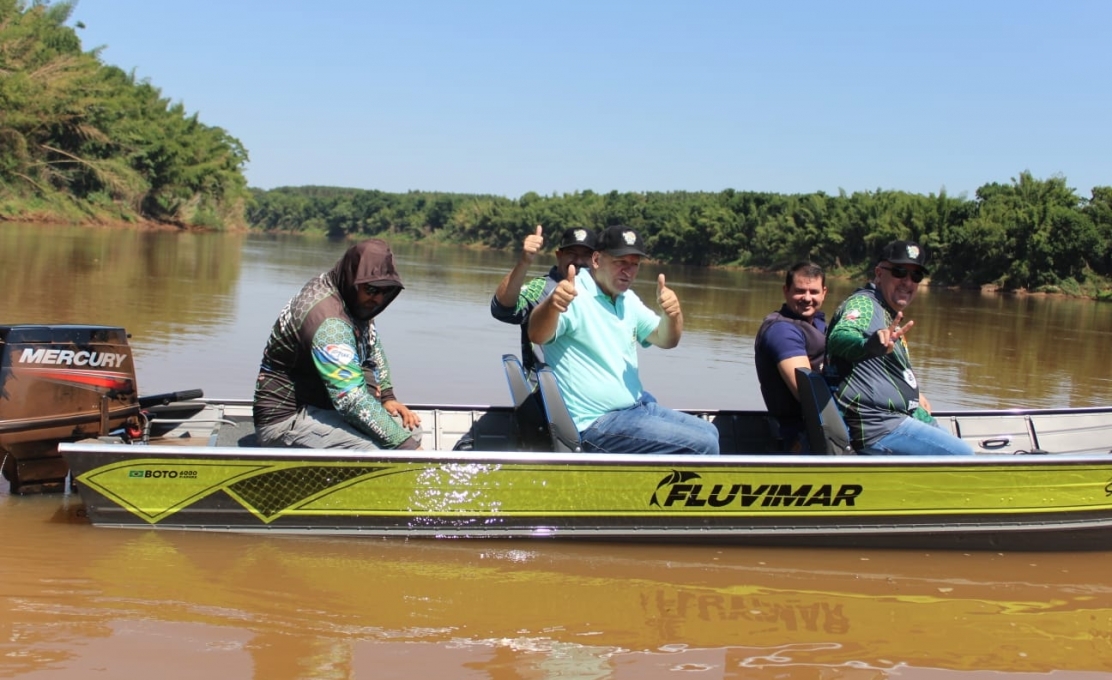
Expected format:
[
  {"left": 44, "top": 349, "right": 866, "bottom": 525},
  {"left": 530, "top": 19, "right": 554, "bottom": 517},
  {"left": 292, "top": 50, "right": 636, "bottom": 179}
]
[{"left": 529, "top": 226, "right": 718, "bottom": 454}]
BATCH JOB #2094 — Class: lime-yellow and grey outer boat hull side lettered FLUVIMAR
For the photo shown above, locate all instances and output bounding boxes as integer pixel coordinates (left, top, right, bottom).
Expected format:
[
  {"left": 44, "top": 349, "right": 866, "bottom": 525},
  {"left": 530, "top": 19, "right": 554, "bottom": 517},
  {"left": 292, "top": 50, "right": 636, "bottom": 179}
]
[{"left": 61, "top": 443, "right": 1112, "bottom": 550}]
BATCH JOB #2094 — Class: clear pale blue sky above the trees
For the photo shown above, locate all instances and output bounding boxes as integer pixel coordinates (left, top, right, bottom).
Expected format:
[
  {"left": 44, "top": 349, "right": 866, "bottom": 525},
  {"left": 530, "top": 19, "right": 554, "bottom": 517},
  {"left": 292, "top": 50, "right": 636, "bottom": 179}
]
[{"left": 70, "top": 0, "right": 1112, "bottom": 198}]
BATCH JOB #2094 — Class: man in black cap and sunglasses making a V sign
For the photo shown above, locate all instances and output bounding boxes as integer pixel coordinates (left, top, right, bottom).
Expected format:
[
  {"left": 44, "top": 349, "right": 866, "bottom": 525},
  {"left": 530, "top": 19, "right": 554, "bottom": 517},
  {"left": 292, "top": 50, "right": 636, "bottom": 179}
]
[{"left": 824, "top": 241, "right": 973, "bottom": 456}]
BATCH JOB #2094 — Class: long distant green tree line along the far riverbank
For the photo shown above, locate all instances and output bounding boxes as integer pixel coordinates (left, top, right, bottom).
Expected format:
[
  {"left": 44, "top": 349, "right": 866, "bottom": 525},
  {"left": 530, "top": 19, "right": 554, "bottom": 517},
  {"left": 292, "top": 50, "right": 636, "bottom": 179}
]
[{"left": 247, "top": 171, "right": 1112, "bottom": 298}]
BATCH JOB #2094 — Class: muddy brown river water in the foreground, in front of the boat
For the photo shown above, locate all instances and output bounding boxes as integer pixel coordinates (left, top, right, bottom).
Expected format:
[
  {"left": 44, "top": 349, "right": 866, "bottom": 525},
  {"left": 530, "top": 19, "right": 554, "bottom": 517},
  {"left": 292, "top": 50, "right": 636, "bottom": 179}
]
[{"left": 0, "top": 497, "right": 1112, "bottom": 679}]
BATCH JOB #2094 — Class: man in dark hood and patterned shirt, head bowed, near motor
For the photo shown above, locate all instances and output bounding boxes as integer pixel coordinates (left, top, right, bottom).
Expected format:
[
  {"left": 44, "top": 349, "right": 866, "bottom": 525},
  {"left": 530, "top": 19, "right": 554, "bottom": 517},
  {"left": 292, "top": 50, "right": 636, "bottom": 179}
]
[{"left": 255, "top": 239, "right": 420, "bottom": 449}]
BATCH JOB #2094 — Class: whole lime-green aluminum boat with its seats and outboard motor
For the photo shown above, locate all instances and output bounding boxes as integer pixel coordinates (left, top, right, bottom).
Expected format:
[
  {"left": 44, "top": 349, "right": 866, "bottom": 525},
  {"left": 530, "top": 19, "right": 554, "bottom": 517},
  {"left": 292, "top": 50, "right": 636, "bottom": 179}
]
[{"left": 8, "top": 326, "right": 1112, "bottom": 550}]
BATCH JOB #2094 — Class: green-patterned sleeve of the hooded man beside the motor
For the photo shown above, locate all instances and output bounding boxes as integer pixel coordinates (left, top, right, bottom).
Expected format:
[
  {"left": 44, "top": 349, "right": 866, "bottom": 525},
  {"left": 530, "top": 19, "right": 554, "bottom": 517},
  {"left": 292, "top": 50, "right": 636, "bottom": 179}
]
[{"left": 311, "top": 319, "right": 410, "bottom": 449}]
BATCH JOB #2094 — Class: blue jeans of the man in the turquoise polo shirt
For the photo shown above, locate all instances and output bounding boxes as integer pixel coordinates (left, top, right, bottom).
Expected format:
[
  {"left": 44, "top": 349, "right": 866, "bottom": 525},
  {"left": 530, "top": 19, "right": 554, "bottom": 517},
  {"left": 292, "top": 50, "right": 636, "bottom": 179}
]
[{"left": 579, "top": 392, "right": 718, "bottom": 456}]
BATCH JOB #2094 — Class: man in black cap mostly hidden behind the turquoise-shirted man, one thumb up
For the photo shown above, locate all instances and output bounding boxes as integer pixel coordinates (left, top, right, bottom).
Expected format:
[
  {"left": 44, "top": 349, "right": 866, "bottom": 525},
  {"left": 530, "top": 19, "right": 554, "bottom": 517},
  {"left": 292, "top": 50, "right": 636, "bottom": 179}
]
[{"left": 490, "top": 224, "right": 595, "bottom": 370}]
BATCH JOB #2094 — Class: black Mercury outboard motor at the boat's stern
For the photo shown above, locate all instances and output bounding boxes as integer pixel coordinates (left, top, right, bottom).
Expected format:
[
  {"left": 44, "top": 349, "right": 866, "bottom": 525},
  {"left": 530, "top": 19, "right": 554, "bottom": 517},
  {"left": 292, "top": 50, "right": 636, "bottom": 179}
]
[{"left": 0, "top": 324, "right": 201, "bottom": 493}]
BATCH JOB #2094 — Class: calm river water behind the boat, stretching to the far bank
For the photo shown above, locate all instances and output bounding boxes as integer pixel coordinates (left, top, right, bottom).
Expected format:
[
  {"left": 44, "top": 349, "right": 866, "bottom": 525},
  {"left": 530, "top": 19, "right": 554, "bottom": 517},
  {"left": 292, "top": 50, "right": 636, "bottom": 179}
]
[{"left": 0, "top": 223, "right": 1112, "bottom": 409}]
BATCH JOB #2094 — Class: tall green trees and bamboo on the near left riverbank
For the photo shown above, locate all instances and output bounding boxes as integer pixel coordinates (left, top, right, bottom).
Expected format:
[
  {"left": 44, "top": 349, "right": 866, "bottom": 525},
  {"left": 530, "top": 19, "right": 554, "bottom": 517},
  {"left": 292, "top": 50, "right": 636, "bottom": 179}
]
[{"left": 0, "top": 0, "right": 249, "bottom": 228}]
